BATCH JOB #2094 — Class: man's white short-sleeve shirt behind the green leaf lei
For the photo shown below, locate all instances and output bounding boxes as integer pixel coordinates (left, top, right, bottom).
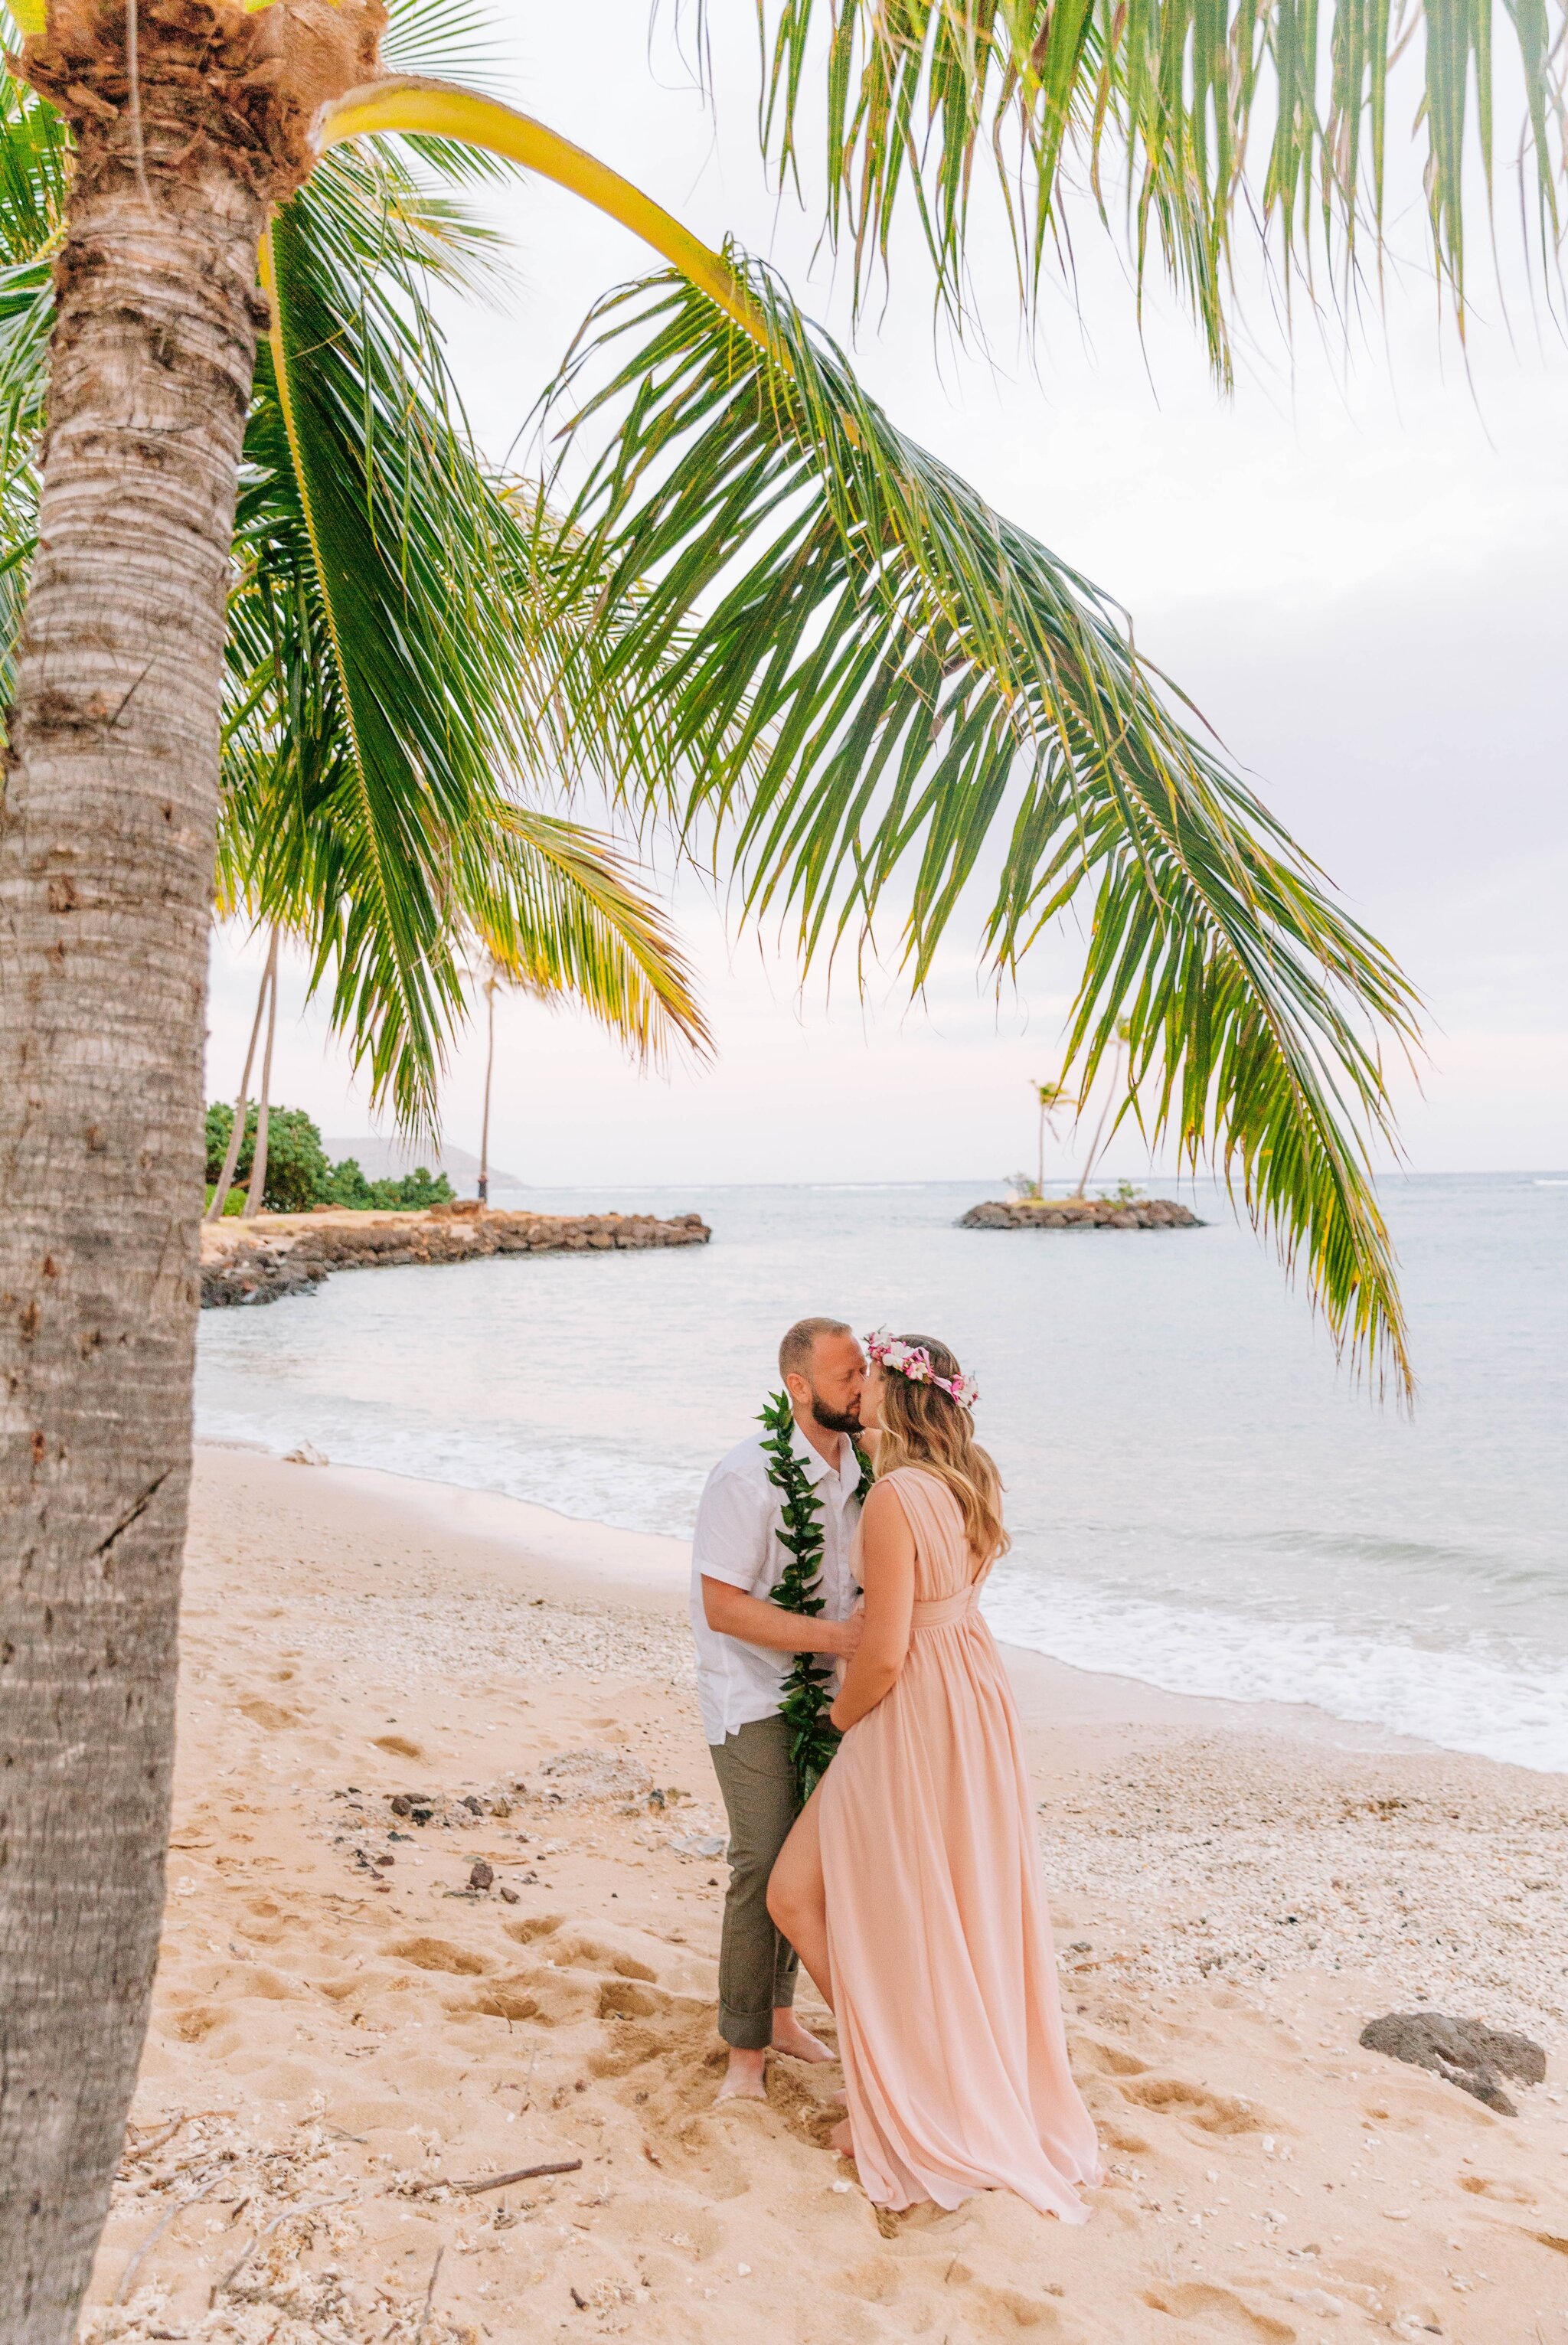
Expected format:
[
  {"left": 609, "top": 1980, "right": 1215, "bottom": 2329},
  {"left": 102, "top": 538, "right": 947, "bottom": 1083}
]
[{"left": 691, "top": 1426, "right": 860, "bottom": 1742}]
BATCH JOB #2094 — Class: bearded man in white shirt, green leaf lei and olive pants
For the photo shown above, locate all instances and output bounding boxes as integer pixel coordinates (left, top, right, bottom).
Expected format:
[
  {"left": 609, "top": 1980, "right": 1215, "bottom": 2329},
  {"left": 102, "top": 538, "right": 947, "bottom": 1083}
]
[{"left": 691, "top": 1318, "right": 865, "bottom": 2101}]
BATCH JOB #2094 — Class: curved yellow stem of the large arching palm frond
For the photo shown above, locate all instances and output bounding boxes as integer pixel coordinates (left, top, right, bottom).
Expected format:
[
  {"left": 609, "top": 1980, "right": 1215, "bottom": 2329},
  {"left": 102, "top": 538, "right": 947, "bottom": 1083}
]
[{"left": 316, "top": 75, "right": 773, "bottom": 349}]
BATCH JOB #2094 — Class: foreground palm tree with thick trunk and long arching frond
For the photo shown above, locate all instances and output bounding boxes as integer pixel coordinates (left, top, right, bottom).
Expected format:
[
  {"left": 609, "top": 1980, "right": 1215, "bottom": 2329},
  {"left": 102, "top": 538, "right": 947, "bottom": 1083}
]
[{"left": 0, "top": 0, "right": 1452, "bottom": 2345}]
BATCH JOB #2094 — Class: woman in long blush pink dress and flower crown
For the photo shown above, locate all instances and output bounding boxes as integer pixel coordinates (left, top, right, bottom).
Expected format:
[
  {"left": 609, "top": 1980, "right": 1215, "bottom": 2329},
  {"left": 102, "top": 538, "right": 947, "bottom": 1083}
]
[{"left": 769, "top": 1334, "right": 1099, "bottom": 2223}]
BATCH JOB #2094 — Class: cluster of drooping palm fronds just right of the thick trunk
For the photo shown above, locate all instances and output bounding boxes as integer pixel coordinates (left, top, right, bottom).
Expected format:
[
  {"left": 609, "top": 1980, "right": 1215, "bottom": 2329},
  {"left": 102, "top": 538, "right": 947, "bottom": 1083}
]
[{"left": 220, "top": 152, "right": 705, "bottom": 1130}]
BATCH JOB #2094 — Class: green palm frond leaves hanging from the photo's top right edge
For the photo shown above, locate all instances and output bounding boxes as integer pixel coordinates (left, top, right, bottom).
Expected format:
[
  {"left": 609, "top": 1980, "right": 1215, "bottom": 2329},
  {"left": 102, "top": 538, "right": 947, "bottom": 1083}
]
[{"left": 760, "top": 0, "right": 1568, "bottom": 375}]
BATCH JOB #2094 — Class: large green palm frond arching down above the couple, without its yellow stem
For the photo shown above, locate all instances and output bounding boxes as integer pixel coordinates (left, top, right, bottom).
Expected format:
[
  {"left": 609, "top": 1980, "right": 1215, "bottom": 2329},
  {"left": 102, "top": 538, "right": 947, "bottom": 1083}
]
[{"left": 541, "top": 253, "right": 1416, "bottom": 1377}]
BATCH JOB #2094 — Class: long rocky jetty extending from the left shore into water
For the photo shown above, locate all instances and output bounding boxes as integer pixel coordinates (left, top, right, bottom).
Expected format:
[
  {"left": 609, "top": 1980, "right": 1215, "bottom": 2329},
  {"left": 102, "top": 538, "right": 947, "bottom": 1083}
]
[{"left": 201, "top": 1198, "right": 713, "bottom": 1311}]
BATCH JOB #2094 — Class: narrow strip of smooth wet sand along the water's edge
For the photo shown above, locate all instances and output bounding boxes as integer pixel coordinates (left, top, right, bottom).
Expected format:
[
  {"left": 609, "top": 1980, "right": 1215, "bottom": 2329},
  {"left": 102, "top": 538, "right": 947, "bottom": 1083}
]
[{"left": 197, "top": 1440, "right": 1472, "bottom": 1775}]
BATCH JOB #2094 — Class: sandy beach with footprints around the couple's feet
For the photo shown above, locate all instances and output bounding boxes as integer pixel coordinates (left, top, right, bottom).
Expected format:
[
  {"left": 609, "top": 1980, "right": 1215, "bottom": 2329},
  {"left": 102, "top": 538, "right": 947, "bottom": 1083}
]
[{"left": 84, "top": 1449, "right": 1568, "bottom": 2345}]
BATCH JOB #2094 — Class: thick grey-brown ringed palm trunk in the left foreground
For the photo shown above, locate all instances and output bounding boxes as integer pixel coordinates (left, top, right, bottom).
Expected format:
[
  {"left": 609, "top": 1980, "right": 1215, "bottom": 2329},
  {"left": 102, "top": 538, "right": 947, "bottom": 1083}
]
[{"left": 0, "top": 91, "right": 265, "bottom": 2345}]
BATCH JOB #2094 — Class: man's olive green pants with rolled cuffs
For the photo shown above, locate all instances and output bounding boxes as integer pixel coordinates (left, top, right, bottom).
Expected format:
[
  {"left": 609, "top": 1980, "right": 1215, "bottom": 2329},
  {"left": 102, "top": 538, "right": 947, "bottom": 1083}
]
[{"left": 708, "top": 1712, "right": 799, "bottom": 2052}]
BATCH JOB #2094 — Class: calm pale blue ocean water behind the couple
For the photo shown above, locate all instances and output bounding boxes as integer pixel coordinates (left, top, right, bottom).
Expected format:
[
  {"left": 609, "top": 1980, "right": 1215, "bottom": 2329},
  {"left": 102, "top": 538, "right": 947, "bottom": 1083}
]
[{"left": 197, "top": 1175, "right": 1568, "bottom": 1771}]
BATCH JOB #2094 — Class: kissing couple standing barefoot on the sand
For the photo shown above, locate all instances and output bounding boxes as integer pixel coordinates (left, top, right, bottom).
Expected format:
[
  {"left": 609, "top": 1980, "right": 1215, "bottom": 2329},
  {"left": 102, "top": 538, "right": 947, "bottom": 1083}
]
[{"left": 691, "top": 1318, "right": 1099, "bottom": 2223}]
